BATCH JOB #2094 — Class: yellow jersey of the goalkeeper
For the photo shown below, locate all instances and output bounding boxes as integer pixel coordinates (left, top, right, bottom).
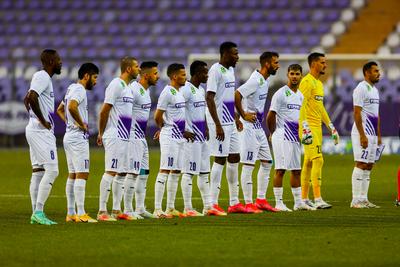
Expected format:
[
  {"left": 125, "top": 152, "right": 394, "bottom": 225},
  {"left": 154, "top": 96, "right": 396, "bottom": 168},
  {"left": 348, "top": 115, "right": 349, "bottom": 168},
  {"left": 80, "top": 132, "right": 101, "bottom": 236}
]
[{"left": 299, "top": 73, "right": 331, "bottom": 127}]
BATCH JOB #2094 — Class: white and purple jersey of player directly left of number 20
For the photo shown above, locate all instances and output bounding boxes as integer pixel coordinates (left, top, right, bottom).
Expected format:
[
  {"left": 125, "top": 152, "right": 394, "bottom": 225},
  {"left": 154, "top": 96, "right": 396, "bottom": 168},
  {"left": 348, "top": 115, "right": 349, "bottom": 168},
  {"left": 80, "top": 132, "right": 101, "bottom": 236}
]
[{"left": 157, "top": 85, "right": 185, "bottom": 140}]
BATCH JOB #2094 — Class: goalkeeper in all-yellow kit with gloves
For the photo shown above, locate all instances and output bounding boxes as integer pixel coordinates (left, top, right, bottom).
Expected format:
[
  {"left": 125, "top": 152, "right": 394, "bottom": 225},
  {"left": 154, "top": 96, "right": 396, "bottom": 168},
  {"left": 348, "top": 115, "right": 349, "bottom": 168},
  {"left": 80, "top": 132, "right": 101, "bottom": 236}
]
[{"left": 299, "top": 53, "right": 339, "bottom": 209}]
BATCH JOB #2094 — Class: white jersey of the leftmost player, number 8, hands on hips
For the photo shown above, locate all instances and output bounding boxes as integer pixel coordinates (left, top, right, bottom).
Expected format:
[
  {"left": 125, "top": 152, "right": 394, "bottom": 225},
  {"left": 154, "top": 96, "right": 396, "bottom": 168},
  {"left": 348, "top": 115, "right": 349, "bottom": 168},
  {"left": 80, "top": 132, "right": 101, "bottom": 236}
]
[{"left": 28, "top": 70, "right": 55, "bottom": 131}]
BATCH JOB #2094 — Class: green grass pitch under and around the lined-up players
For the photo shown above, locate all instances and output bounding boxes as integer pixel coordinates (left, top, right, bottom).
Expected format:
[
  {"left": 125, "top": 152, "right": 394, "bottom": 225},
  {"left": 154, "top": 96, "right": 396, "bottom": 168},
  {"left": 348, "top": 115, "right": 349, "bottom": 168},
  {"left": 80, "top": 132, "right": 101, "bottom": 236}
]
[{"left": 0, "top": 149, "right": 400, "bottom": 266}]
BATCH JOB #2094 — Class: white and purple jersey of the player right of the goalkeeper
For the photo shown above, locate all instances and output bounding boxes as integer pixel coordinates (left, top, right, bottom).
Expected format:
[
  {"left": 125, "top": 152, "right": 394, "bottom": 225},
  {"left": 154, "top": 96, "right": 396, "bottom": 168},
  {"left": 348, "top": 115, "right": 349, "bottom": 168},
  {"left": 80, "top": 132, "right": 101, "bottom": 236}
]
[{"left": 351, "top": 81, "right": 379, "bottom": 136}]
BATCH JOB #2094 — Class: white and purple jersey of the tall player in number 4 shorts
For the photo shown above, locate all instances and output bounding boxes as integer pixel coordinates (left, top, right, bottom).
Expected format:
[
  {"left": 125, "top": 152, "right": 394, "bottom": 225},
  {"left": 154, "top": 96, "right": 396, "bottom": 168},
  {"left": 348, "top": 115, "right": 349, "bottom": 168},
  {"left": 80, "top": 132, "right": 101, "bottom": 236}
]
[{"left": 207, "top": 63, "right": 235, "bottom": 125}]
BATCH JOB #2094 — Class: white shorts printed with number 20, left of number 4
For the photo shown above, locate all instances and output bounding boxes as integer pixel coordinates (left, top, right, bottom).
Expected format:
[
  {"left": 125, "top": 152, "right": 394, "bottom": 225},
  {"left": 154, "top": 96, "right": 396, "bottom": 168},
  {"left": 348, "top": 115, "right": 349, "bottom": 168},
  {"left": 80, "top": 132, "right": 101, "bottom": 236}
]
[{"left": 182, "top": 142, "right": 210, "bottom": 175}]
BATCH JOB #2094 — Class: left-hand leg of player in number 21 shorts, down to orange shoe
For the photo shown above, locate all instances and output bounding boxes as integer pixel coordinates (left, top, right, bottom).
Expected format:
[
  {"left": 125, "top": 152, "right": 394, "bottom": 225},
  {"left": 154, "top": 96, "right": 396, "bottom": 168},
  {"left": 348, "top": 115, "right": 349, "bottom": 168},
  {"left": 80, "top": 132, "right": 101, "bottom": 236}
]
[{"left": 97, "top": 138, "right": 119, "bottom": 221}]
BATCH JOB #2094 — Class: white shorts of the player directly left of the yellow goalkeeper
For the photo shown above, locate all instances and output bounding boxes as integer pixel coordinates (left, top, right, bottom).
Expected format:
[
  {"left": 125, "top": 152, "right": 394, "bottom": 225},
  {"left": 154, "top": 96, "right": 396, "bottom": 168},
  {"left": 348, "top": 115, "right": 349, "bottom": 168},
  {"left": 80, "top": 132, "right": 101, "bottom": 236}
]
[{"left": 272, "top": 129, "right": 301, "bottom": 170}]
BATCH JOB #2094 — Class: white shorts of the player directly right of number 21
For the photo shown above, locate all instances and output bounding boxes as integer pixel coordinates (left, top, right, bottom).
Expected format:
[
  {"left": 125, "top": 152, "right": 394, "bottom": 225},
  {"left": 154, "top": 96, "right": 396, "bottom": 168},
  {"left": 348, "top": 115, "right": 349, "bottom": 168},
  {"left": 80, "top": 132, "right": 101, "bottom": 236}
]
[{"left": 128, "top": 138, "right": 149, "bottom": 174}]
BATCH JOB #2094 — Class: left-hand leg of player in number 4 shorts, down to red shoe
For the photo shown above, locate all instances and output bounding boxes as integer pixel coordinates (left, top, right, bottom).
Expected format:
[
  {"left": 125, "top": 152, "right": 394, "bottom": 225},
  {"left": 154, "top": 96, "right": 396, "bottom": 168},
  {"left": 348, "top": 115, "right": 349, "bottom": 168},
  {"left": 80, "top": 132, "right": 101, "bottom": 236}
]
[{"left": 208, "top": 124, "right": 229, "bottom": 212}]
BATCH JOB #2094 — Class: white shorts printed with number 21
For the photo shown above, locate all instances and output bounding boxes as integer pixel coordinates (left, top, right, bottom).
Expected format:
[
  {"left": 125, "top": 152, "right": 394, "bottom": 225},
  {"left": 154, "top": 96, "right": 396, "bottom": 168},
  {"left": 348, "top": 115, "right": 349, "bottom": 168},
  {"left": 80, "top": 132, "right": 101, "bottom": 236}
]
[{"left": 103, "top": 138, "right": 129, "bottom": 173}]
